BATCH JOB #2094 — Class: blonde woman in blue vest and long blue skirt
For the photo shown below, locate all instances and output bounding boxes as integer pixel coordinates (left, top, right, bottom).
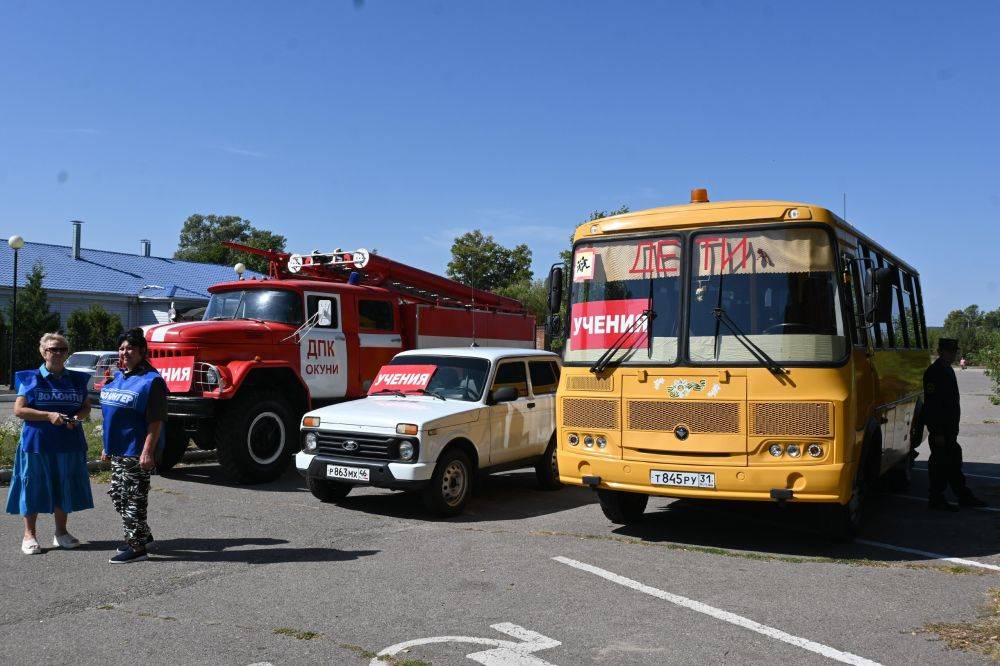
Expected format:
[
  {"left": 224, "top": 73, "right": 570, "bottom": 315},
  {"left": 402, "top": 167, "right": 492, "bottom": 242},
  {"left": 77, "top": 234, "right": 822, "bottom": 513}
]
[{"left": 7, "top": 333, "right": 94, "bottom": 555}]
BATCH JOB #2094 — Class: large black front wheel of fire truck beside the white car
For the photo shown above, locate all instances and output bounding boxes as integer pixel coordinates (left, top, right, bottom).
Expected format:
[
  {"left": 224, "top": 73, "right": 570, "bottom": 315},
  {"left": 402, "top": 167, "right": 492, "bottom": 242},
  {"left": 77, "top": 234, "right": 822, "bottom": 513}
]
[{"left": 215, "top": 391, "right": 297, "bottom": 483}]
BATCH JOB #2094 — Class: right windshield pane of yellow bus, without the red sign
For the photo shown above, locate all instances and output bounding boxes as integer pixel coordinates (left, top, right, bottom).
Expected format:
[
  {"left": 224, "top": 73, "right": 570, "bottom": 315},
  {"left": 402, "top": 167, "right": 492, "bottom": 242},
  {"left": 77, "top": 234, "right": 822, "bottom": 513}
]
[{"left": 688, "top": 228, "right": 847, "bottom": 363}]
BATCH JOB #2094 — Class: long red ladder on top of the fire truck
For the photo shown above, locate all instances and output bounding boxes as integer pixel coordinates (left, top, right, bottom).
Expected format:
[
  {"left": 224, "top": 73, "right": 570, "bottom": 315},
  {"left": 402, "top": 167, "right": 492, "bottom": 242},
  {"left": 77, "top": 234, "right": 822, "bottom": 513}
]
[{"left": 224, "top": 243, "right": 526, "bottom": 314}]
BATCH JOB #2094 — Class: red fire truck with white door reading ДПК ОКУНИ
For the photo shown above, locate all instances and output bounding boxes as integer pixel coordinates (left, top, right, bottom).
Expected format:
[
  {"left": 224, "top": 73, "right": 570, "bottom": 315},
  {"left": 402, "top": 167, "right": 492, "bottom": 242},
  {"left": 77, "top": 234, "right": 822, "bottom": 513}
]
[{"left": 133, "top": 244, "right": 535, "bottom": 483}]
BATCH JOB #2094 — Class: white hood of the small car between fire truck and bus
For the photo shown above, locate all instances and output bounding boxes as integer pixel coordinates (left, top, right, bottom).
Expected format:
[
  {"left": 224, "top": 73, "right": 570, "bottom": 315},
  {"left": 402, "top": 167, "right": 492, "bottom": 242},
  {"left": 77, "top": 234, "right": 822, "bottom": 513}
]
[{"left": 307, "top": 396, "right": 482, "bottom": 432}]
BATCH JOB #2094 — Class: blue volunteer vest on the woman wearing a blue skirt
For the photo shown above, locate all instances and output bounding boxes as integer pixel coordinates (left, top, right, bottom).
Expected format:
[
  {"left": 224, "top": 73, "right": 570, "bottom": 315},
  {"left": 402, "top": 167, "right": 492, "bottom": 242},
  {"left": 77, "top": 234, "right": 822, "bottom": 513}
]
[{"left": 14, "top": 364, "right": 90, "bottom": 453}]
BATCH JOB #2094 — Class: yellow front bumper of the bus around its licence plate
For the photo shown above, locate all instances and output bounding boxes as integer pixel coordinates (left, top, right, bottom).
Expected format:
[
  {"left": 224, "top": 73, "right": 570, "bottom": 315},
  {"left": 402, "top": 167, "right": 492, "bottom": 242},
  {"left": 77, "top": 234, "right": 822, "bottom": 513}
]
[{"left": 557, "top": 450, "right": 850, "bottom": 504}]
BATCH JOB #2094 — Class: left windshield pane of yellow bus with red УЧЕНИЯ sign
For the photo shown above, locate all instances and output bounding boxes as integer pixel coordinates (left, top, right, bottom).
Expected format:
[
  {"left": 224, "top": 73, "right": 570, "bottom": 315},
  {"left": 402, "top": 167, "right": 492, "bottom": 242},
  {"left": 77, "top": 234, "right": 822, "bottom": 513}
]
[{"left": 565, "top": 236, "right": 681, "bottom": 364}]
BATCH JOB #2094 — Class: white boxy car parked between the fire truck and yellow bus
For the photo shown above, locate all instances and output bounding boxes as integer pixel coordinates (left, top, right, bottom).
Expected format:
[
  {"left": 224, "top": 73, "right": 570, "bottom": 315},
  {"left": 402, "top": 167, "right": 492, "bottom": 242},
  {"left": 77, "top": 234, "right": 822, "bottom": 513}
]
[{"left": 295, "top": 347, "right": 560, "bottom": 516}]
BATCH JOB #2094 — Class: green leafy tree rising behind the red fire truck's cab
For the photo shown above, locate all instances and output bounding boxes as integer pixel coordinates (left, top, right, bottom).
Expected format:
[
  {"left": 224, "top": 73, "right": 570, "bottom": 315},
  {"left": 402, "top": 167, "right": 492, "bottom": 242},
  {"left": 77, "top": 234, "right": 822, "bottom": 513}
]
[{"left": 174, "top": 214, "right": 286, "bottom": 274}]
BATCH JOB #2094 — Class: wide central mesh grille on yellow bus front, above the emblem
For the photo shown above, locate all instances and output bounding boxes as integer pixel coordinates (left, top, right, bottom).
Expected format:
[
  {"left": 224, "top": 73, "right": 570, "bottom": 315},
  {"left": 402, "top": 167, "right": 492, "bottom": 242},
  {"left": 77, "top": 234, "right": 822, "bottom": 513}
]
[{"left": 628, "top": 400, "right": 743, "bottom": 435}]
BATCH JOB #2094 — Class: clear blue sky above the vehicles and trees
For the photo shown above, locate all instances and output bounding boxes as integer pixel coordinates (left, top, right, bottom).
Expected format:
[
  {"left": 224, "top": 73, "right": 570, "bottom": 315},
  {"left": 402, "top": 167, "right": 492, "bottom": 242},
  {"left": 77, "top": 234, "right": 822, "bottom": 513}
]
[{"left": 0, "top": 0, "right": 1000, "bottom": 324}]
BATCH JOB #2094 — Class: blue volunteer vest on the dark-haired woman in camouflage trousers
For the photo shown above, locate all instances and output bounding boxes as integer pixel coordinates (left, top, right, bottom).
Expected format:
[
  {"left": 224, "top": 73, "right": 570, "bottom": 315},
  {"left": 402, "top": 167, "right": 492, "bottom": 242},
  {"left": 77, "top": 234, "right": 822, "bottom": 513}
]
[{"left": 101, "top": 366, "right": 167, "bottom": 457}]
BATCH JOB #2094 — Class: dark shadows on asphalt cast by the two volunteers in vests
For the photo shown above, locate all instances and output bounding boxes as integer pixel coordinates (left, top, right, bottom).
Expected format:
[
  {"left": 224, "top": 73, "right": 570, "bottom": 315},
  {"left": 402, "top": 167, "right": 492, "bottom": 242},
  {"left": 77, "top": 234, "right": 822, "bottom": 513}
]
[{"left": 80, "top": 538, "right": 379, "bottom": 564}]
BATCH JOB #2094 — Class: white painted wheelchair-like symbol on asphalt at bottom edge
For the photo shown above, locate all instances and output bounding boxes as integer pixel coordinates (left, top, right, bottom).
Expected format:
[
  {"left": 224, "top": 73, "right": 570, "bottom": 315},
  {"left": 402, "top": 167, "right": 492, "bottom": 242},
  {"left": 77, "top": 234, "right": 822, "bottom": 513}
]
[{"left": 369, "top": 622, "right": 562, "bottom": 666}]
